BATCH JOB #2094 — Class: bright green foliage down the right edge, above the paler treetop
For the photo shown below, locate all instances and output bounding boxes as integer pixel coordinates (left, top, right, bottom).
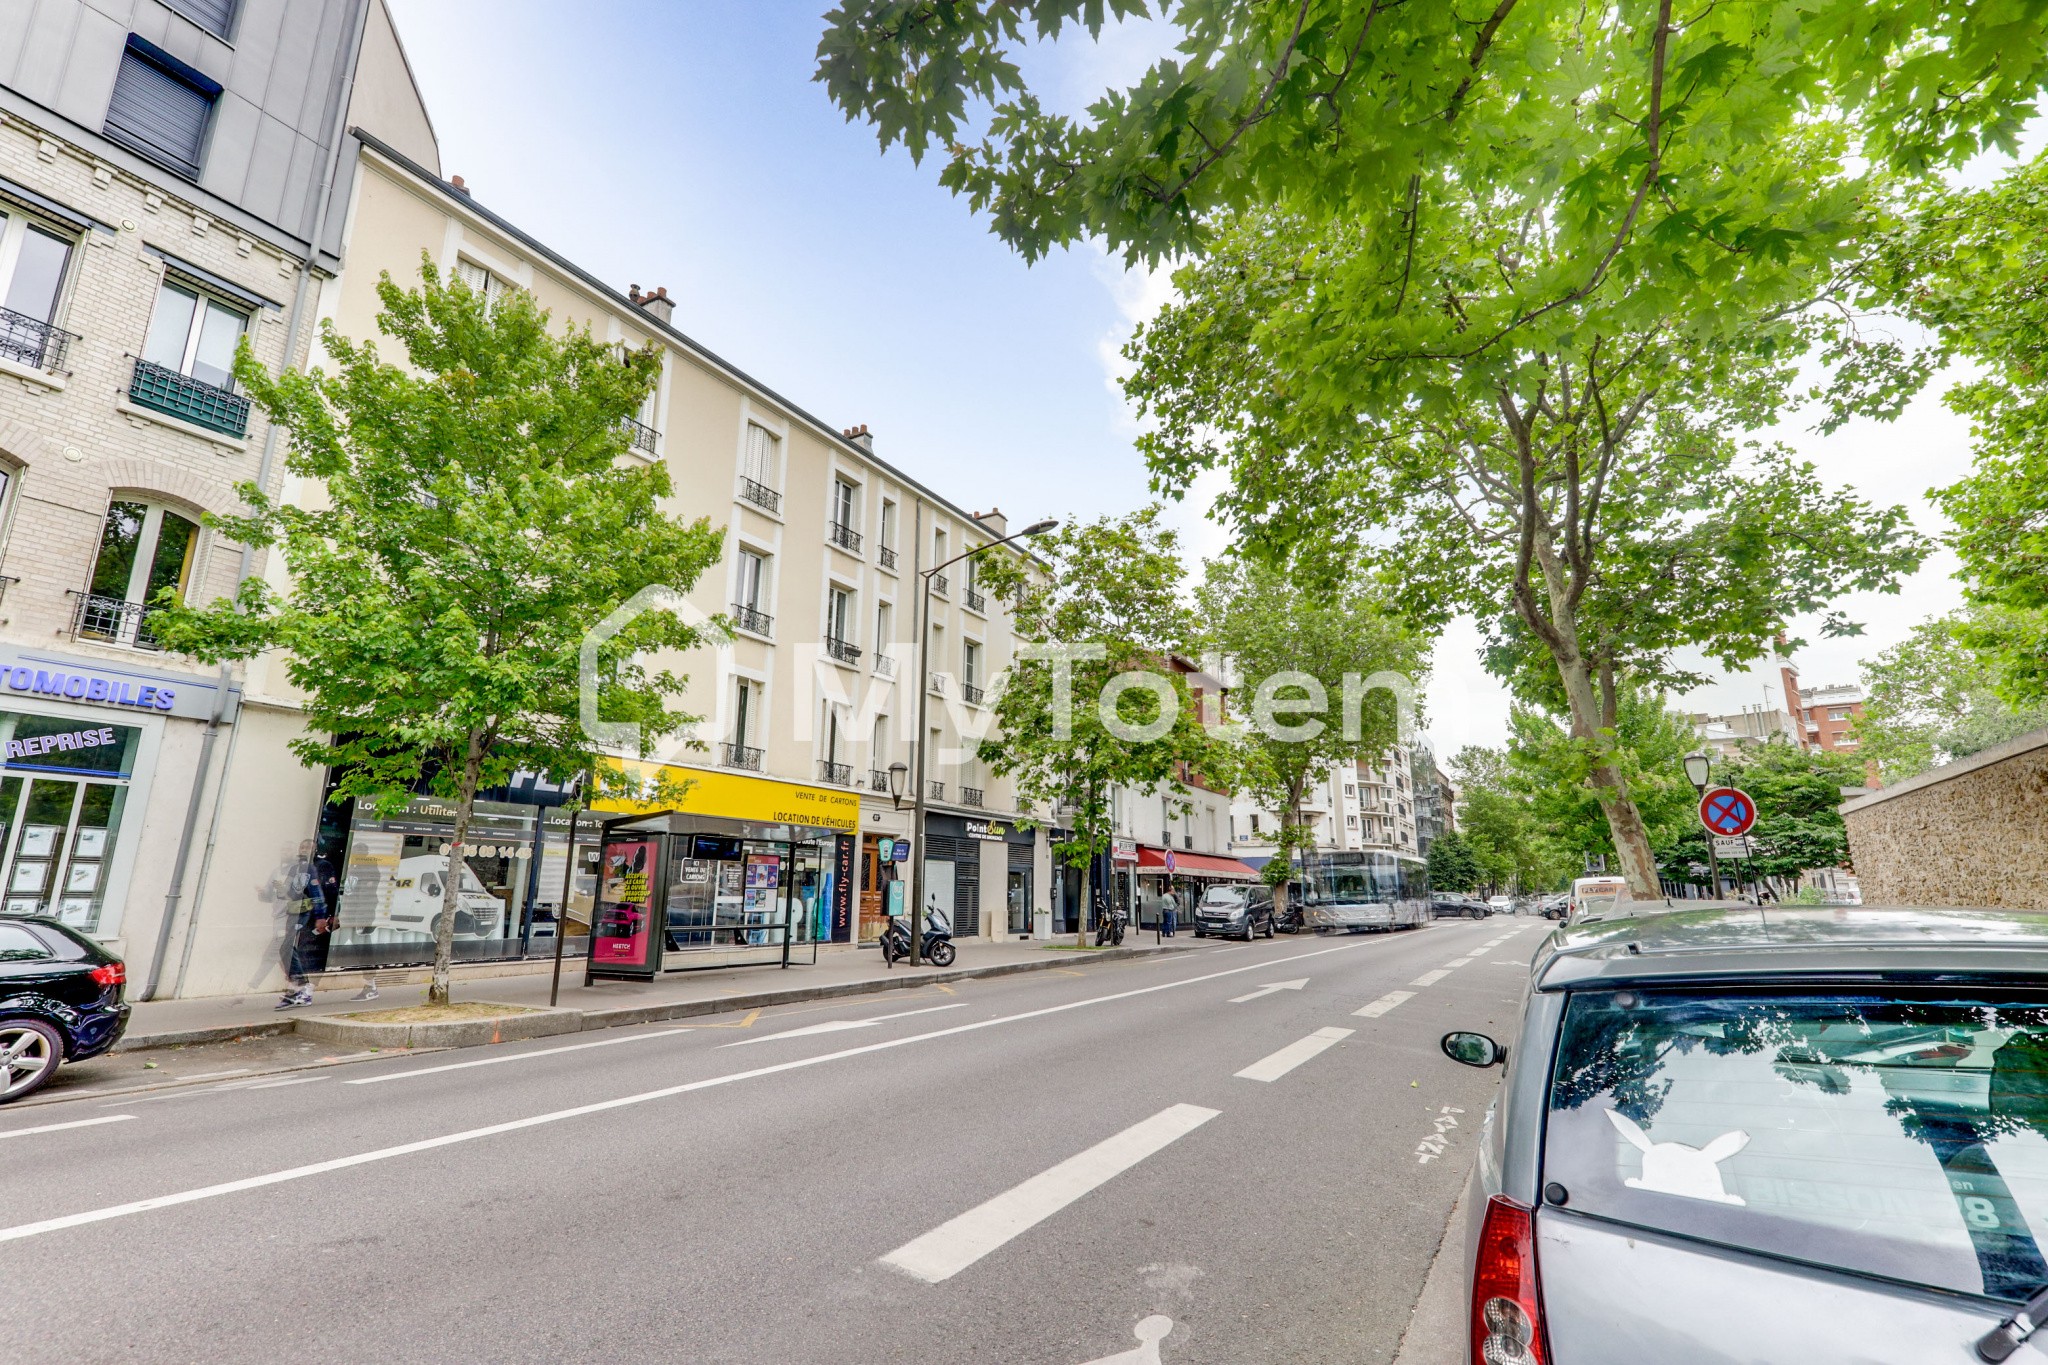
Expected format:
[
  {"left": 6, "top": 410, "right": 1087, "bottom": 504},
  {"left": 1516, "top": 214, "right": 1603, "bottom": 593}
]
[{"left": 1880, "top": 158, "right": 2048, "bottom": 706}]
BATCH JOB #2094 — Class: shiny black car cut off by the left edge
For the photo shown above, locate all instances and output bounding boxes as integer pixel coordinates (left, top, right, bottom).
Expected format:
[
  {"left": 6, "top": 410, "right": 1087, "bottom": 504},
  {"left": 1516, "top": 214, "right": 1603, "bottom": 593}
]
[{"left": 0, "top": 915, "right": 129, "bottom": 1105}]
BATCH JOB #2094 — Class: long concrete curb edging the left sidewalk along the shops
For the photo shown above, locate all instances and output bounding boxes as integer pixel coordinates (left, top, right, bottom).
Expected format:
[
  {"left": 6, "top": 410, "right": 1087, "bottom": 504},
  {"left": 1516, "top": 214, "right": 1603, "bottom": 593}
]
[{"left": 113, "top": 943, "right": 1196, "bottom": 1052}]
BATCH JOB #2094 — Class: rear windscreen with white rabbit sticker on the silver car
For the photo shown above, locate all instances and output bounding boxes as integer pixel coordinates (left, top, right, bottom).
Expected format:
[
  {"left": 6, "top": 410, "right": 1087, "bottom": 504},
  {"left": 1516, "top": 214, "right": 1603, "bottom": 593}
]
[{"left": 1544, "top": 990, "right": 2048, "bottom": 1300}]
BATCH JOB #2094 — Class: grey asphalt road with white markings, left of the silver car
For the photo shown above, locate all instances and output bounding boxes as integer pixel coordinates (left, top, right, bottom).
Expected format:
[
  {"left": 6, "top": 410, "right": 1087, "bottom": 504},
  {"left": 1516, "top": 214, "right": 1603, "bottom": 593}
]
[{"left": 0, "top": 919, "right": 1548, "bottom": 1365}]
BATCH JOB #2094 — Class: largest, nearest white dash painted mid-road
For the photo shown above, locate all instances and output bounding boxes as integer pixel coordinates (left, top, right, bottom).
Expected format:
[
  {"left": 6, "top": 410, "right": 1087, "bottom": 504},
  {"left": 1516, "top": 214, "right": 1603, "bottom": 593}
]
[{"left": 883, "top": 1105, "right": 1219, "bottom": 1285}]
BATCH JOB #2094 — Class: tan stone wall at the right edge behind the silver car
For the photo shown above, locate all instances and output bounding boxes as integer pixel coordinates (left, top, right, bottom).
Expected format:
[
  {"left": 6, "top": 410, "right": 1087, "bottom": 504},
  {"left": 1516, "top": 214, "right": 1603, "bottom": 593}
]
[{"left": 1841, "top": 731, "right": 2048, "bottom": 911}]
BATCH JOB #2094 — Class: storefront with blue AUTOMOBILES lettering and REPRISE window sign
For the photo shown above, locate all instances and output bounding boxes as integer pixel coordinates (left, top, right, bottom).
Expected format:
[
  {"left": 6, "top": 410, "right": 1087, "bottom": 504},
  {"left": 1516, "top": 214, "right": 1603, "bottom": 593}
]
[{"left": 0, "top": 649, "right": 240, "bottom": 939}]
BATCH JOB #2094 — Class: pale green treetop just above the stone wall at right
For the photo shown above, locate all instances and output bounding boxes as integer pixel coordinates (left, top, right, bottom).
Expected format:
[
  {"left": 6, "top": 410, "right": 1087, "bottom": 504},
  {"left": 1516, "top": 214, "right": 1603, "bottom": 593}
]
[{"left": 1853, "top": 608, "right": 2048, "bottom": 782}]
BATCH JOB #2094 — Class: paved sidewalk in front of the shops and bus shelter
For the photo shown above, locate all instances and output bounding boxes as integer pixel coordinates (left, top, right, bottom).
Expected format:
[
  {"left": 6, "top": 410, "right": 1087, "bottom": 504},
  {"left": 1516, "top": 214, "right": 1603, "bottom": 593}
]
[{"left": 119, "top": 933, "right": 1202, "bottom": 1052}]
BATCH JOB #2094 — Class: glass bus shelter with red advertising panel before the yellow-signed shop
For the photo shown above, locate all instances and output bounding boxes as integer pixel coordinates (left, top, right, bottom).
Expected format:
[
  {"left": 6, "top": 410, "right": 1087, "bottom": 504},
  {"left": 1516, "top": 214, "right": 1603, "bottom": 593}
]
[{"left": 584, "top": 810, "right": 838, "bottom": 984}]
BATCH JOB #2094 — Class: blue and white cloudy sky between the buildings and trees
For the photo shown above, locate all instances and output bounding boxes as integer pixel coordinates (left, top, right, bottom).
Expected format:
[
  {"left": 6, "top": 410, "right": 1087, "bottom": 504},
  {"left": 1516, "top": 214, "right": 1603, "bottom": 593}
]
[{"left": 389, "top": 0, "right": 2015, "bottom": 755}]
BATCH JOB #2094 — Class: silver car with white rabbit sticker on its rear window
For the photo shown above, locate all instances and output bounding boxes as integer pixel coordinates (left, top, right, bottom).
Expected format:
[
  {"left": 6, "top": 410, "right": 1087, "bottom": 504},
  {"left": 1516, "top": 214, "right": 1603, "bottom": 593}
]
[{"left": 1444, "top": 907, "right": 2048, "bottom": 1365}]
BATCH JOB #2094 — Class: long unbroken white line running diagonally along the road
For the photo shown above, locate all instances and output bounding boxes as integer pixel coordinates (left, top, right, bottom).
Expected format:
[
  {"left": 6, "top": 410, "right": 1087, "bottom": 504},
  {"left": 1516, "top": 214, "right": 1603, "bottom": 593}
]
[{"left": 0, "top": 939, "right": 1372, "bottom": 1242}]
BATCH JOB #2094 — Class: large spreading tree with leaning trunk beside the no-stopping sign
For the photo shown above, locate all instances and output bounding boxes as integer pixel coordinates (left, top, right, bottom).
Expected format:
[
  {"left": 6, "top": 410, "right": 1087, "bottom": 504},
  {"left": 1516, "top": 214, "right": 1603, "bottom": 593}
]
[{"left": 1126, "top": 199, "right": 1923, "bottom": 896}]
